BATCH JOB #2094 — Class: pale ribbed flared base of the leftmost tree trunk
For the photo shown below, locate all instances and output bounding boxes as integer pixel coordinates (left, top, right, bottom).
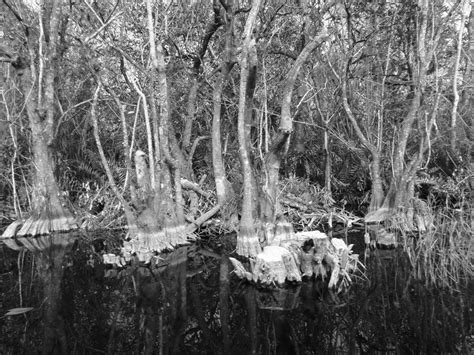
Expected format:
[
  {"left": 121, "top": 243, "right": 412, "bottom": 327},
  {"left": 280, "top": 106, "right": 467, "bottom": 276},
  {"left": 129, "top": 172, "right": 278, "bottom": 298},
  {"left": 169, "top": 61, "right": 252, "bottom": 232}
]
[{"left": 1, "top": 207, "right": 79, "bottom": 239}]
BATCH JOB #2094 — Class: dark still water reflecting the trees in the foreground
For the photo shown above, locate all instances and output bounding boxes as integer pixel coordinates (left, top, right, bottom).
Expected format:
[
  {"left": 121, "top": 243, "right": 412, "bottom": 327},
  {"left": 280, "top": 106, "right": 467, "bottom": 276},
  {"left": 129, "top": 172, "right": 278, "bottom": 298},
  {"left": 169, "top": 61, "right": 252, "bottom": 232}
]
[{"left": 0, "top": 235, "right": 474, "bottom": 354}]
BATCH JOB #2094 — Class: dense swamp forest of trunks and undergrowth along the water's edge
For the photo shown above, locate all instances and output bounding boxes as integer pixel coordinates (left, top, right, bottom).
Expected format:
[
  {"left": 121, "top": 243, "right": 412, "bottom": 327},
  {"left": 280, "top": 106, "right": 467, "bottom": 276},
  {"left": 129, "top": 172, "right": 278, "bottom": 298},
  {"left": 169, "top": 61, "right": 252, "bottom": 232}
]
[{"left": 0, "top": 0, "right": 474, "bottom": 279}]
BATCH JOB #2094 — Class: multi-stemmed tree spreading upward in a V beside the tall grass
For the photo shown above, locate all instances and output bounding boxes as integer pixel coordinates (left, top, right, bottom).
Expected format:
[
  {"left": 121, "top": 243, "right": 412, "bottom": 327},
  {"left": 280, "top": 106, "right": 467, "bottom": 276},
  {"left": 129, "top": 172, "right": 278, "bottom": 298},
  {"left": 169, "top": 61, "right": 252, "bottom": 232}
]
[{"left": 336, "top": 1, "right": 459, "bottom": 230}]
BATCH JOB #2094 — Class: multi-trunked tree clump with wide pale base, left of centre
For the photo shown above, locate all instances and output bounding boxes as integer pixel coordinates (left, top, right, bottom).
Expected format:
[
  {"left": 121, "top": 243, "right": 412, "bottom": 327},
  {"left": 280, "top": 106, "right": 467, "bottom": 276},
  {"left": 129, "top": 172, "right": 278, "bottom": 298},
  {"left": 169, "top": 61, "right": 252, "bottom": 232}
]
[{"left": 86, "top": 1, "right": 220, "bottom": 255}]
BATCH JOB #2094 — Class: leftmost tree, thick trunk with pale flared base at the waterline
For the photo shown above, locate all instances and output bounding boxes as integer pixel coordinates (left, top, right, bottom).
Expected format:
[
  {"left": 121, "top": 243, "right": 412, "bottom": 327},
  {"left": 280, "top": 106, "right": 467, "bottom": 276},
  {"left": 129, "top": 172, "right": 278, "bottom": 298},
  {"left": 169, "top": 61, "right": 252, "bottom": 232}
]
[{"left": 0, "top": 0, "right": 78, "bottom": 237}]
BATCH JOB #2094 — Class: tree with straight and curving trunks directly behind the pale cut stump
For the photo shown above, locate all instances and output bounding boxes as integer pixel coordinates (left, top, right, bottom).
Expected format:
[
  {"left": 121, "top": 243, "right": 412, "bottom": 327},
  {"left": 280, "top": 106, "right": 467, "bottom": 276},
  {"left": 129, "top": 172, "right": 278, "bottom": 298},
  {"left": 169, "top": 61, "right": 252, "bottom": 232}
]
[{"left": 237, "top": 2, "right": 332, "bottom": 256}]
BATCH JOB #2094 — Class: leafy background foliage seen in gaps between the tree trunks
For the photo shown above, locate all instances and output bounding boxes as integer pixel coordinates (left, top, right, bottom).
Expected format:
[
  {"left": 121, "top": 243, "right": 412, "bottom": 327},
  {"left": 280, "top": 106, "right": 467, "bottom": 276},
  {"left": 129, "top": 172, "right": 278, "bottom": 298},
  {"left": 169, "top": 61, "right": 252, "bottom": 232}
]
[{"left": 2, "top": 1, "right": 470, "bottom": 214}]
